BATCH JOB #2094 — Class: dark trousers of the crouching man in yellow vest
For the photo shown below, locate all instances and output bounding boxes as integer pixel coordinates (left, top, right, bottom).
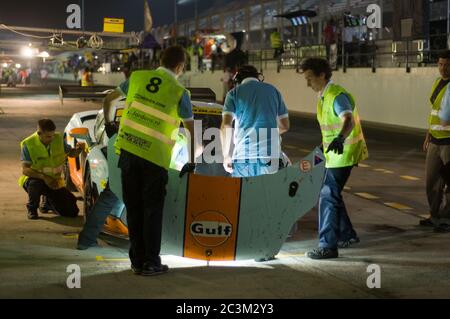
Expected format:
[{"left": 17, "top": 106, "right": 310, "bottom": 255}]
[{"left": 24, "top": 178, "right": 79, "bottom": 217}]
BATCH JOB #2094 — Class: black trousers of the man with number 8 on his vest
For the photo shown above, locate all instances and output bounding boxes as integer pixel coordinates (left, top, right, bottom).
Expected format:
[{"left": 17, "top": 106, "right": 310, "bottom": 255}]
[{"left": 119, "top": 150, "right": 168, "bottom": 266}]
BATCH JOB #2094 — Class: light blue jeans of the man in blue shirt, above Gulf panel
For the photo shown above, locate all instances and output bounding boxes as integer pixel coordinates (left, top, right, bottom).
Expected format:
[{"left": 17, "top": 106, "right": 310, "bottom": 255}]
[{"left": 231, "top": 159, "right": 280, "bottom": 178}]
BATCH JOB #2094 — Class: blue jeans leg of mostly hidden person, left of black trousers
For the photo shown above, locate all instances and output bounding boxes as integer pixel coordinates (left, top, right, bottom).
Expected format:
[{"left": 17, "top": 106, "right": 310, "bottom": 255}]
[{"left": 78, "top": 188, "right": 121, "bottom": 246}]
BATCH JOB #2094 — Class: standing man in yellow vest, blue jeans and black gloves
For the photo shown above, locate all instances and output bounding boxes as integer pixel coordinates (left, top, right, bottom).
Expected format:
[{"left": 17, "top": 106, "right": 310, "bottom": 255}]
[{"left": 301, "top": 58, "right": 368, "bottom": 259}]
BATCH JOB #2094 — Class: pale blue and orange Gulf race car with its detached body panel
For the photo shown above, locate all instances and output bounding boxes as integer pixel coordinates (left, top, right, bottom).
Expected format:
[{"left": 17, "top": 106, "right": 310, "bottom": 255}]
[{"left": 70, "top": 88, "right": 316, "bottom": 261}]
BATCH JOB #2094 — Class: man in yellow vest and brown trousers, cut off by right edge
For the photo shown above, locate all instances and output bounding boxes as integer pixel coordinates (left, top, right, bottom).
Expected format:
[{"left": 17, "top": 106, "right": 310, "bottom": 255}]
[{"left": 420, "top": 51, "right": 450, "bottom": 231}]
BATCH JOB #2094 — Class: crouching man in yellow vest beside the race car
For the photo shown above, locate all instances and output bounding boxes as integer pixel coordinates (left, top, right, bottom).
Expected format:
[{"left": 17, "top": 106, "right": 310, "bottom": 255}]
[{"left": 19, "top": 119, "right": 82, "bottom": 219}]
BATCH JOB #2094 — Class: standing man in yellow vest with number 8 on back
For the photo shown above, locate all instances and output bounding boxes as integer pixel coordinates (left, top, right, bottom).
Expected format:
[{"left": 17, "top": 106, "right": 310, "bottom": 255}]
[{"left": 115, "top": 46, "right": 195, "bottom": 276}]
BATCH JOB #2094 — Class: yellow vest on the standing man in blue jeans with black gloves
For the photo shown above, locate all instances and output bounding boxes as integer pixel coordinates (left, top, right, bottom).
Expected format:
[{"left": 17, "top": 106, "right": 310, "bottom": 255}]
[{"left": 317, "top": 83, "right": 369, "bottom": 168}]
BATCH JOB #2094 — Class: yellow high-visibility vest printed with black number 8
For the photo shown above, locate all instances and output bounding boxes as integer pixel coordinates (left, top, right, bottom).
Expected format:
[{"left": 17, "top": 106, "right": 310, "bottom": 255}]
[{"left": 115, "top": 69, "right": 185, "bottom": 169}]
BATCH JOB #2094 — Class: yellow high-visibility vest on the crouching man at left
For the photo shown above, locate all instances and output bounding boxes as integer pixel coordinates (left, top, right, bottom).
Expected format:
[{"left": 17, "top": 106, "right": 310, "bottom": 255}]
[{"left": 18, "top": 132, "right": 66, "bottom": 188}]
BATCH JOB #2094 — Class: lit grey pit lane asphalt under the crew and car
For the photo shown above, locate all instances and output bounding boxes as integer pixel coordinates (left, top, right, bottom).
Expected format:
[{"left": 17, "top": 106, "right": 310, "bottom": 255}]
[{"left": 0, "top": 88, "right": 450, "bottom": 298}]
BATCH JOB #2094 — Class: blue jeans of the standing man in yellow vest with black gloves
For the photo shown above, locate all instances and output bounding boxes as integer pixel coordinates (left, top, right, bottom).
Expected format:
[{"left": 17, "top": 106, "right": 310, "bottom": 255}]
[{"left": 319, "top": 167, "right": 357, "bottom": 249}]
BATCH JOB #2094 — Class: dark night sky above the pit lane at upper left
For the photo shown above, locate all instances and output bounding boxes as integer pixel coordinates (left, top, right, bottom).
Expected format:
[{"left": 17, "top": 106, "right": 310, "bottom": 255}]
[{"left": 0, "top": 0, "right": 226, "bottom": 32}]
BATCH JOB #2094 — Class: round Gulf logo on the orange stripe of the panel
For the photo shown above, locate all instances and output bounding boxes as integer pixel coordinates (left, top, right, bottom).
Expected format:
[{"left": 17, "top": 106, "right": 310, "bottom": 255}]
[{"left": 190, "top": 211, "right": 233, "bottom": 247}]
